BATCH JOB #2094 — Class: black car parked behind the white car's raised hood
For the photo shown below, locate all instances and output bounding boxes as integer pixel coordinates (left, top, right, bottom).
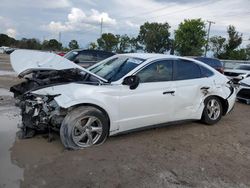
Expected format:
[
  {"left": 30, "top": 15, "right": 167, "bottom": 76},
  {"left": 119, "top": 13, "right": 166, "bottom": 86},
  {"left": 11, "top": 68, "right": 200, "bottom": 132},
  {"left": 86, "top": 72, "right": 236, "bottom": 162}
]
[{"left": 64, "top": 49, "right": 115, "bottom": 68}]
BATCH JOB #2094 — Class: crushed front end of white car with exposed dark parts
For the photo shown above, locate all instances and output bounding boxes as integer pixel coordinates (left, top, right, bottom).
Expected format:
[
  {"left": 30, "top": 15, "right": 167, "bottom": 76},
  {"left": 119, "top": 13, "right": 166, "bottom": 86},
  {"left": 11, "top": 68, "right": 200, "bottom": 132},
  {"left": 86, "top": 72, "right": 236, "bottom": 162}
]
[{"left": 18, "top": 93, "right": 66, "bottom": 138}]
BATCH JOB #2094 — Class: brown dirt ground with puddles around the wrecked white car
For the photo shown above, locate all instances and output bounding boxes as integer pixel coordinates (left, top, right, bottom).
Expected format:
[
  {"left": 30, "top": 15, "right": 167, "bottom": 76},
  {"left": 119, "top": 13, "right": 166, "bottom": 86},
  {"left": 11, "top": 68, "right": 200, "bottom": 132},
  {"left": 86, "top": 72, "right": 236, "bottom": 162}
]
[{"left": 0, "top": 53, "right": 250, "bottom": 188}]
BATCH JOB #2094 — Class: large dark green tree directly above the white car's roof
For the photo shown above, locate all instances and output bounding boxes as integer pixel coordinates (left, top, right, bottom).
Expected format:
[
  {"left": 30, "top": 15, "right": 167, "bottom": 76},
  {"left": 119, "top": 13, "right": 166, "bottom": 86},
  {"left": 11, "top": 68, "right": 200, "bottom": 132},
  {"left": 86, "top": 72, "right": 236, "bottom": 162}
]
[{"left": 137, "top": 22, "right": 170, "bottom": 53}]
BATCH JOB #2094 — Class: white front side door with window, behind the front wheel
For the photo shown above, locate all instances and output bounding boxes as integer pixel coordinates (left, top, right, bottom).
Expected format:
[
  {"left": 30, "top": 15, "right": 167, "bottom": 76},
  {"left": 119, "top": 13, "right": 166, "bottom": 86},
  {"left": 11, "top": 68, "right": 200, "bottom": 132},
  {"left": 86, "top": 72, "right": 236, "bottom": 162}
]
[{"left": 118, "top": 60, "right": 176, "bottom": 131}]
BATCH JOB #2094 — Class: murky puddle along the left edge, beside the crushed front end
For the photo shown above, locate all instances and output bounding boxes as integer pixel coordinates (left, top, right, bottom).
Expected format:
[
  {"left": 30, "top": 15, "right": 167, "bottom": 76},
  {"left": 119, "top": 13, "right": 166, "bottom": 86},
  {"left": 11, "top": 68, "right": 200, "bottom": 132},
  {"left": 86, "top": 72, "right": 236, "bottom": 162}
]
[{"left": 0, "top": 89, "right": 23, "bottom": 188}]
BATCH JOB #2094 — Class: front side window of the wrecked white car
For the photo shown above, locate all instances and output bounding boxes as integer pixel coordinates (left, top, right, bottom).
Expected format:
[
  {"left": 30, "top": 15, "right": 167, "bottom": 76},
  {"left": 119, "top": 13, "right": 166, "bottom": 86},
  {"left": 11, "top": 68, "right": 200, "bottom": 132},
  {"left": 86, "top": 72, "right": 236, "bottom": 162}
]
[{"left": 136, "top": 60, "right": 173, "bottom": 83}]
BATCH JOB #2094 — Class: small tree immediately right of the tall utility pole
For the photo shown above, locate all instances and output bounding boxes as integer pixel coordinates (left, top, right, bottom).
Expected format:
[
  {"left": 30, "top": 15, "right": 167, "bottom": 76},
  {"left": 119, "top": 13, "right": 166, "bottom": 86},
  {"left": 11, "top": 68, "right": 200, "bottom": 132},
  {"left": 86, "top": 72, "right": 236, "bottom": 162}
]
[{"left": 210, "top": 36, "right": 226, "bottom": 57}]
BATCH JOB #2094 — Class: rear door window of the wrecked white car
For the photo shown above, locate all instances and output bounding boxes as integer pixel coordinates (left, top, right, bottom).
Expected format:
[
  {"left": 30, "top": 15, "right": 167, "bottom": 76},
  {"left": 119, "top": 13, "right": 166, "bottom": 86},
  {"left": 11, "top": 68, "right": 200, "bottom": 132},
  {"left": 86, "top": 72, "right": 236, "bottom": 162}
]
[{"left": 174, "top": 59, "right": 201, "bottom": 80}]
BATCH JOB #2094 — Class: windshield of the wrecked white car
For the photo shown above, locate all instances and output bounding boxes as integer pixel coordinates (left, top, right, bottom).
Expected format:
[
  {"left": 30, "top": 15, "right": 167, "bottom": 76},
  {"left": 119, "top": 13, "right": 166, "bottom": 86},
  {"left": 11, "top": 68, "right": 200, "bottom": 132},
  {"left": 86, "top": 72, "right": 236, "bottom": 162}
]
[{"left": 90, "top": 56, "right": 144, "bottom": 82}]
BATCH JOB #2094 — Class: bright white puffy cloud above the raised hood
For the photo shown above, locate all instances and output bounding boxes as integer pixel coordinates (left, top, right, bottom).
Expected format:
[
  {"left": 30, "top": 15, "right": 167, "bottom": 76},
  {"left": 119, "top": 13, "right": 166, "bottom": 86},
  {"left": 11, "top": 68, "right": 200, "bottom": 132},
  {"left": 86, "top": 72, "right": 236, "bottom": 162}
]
[{"left": 43, "top": 8, "right": 116, "bottom": 32}]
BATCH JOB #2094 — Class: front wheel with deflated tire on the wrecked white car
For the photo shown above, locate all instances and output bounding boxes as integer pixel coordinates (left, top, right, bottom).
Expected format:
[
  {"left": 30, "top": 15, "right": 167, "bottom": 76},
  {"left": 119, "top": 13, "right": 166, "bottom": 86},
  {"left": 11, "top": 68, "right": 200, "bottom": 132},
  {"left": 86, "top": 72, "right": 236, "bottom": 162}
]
[{"left": 60, "top": 106, "right": 109, "bottom": 149}]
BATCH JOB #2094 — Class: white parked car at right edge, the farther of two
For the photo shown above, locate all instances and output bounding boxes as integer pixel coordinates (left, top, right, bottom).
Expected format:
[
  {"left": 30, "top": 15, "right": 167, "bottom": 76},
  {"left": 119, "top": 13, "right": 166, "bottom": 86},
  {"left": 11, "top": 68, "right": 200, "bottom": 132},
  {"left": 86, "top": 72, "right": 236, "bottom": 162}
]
[{"left": 224, "top": 64, "right": 250, "bottom": 83}]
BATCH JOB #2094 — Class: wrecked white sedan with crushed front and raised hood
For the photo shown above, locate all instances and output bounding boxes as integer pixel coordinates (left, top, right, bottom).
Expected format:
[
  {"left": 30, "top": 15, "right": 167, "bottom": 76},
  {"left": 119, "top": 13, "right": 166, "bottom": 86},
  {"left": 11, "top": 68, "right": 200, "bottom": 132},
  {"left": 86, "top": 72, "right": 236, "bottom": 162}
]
[{"left": 11, "top": 50, "right": 236, "bottom": 149}]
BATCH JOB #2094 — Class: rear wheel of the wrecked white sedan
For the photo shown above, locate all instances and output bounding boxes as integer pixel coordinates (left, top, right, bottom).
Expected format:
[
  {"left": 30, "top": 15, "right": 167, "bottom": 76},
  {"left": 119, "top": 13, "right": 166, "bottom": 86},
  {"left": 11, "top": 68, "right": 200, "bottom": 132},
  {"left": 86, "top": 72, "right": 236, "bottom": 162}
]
[{"left": 202, "top": 96, "right": 222, "bottom": 125}]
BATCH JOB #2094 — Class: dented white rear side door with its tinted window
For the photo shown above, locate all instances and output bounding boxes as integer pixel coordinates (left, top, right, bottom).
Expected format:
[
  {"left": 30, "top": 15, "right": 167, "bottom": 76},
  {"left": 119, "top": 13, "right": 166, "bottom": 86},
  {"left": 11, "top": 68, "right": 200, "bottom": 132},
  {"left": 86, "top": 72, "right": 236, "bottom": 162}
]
[{"left": 173, "top": 59, "right": 212, "bottom": 120}]
